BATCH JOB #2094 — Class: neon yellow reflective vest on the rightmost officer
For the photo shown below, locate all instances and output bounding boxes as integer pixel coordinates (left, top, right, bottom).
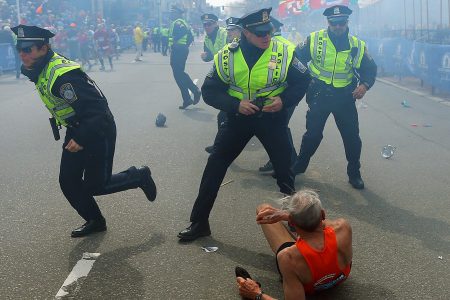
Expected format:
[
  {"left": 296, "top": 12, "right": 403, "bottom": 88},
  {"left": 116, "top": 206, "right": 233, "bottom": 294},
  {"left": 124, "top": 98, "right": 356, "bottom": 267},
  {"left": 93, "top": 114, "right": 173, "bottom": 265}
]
[{"left": 309, "top": 29, "right": 365, "bottom": 88}]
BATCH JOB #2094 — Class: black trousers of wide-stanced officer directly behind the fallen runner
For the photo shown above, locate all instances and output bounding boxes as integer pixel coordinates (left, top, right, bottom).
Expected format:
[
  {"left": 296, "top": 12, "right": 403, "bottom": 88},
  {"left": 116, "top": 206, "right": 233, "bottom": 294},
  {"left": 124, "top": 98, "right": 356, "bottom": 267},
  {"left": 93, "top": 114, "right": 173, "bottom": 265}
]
[{"left": 190, "top": 112, "right": 295, "bottom": 222}]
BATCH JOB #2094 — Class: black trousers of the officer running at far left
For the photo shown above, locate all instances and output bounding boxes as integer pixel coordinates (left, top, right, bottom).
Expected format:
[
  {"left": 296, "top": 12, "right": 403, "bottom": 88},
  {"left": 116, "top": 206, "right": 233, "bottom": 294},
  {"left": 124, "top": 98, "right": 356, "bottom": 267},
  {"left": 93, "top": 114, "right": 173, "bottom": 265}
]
[{"left": 59, "top": 122, "right": 140, "bottom": 221}]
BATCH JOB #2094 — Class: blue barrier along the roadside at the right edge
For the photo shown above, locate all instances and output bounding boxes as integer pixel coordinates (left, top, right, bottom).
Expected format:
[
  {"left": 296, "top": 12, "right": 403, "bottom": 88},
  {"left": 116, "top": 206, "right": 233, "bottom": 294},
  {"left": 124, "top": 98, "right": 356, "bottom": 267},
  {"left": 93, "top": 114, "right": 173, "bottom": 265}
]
[{"left": 365, "top": 38, "right": 450, "bottom": 92}]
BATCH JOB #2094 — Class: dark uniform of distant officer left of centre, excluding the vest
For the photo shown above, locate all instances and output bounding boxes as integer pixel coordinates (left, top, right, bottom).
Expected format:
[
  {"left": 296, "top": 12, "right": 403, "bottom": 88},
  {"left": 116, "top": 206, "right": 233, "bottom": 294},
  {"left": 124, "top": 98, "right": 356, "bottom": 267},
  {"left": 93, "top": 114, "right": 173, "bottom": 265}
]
[{"left": 170, "top": 7, "right": 201, "bottom": 109}]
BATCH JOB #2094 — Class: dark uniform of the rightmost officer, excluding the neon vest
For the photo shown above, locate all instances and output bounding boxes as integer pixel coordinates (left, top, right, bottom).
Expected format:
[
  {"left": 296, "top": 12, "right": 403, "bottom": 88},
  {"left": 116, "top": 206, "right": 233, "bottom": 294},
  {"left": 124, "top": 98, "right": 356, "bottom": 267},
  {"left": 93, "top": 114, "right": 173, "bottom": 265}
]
[{"left": 293, "top": 6, "right": 377, "bottom": 188}]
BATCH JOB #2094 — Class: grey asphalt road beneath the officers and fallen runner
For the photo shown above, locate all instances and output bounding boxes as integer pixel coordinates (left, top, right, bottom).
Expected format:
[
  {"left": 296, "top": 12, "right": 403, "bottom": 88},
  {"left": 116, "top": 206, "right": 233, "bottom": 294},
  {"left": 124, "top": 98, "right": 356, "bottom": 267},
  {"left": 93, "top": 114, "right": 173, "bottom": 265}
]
[{"left": 0, "top": 42, "right": 450, "bottom": 299}]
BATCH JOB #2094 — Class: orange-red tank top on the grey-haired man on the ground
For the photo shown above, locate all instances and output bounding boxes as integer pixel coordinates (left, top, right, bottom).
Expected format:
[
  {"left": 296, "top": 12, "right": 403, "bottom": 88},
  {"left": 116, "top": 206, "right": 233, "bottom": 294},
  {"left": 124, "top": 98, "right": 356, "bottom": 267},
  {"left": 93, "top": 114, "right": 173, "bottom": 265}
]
[{"left": 295, "top": 227, "right": 351, "bottom": 294}]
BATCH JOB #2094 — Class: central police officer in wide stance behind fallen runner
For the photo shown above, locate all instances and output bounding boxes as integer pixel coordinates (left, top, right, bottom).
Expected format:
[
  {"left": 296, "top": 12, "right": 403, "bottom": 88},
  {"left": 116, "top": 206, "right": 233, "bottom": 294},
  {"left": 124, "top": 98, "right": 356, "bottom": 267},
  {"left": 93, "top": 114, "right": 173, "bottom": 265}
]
[{"left": 178, "top": 8, "right": 310, "bottom": 240}]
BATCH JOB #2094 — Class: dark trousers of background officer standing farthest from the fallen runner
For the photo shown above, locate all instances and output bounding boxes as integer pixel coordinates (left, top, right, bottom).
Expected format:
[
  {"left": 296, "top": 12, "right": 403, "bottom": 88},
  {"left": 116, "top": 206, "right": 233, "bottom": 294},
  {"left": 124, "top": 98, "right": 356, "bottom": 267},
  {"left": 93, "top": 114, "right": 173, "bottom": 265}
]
[{"left": 170, "top": 45, "right": 199, "bottom": 103}]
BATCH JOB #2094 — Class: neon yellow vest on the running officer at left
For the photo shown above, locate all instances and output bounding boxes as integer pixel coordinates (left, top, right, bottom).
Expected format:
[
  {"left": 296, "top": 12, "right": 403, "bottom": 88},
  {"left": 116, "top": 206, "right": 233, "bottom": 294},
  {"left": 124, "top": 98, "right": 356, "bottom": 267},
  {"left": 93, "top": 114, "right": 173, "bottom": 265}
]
[{"left": 36, "top": 53, "right": 80, "bottom": 127}]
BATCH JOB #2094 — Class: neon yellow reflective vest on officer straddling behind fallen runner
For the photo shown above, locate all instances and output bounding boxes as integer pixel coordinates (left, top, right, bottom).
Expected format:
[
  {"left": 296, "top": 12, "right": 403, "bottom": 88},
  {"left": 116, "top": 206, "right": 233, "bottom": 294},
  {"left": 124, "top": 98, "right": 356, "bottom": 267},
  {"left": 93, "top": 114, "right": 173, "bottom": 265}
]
[{"left": 214, "top": 41, "right": 294, "bottom": 100}]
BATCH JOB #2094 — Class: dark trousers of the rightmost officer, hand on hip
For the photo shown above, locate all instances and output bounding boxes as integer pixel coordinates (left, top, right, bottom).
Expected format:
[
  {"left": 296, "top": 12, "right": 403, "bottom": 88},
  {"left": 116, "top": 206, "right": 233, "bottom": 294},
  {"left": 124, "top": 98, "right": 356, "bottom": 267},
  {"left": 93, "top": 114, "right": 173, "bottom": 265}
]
[{"left": 297, "top": 91, "right": 362, "bottom": 177}]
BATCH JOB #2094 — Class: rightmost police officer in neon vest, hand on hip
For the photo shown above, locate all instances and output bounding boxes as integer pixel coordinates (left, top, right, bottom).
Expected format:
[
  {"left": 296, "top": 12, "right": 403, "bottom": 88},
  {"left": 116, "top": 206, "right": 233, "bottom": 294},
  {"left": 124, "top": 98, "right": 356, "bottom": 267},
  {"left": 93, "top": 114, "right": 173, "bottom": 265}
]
[{"left": 293, "top": 5, "right": 377, "bottom": 189}]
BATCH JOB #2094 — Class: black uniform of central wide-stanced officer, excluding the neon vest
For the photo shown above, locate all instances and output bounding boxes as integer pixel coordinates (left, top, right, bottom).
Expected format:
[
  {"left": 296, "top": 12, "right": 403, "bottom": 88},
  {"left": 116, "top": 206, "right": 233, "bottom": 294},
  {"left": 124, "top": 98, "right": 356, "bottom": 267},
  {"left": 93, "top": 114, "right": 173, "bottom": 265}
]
[{"left": 178, "top": 9, "right": 310, "bottom": 240}]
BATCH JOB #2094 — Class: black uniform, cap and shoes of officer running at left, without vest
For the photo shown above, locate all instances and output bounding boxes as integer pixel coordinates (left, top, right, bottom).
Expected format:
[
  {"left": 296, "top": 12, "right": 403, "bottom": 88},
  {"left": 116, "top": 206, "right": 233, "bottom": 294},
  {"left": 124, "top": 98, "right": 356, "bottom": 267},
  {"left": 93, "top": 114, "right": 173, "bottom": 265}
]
[{"left": 12, "top": 25, "right": 156, "bottom": 237}]
